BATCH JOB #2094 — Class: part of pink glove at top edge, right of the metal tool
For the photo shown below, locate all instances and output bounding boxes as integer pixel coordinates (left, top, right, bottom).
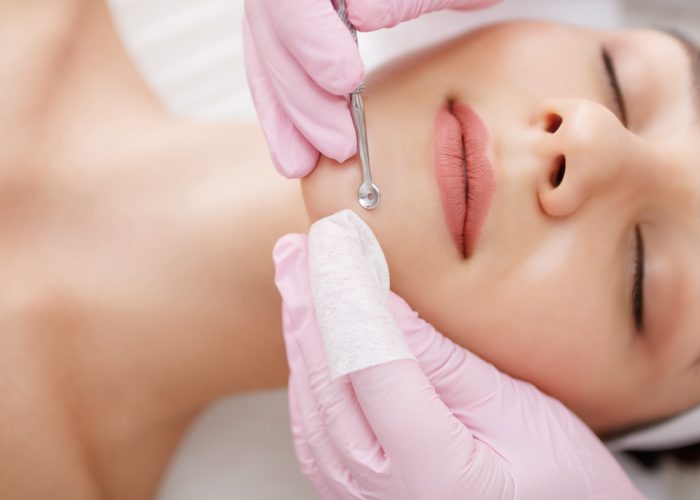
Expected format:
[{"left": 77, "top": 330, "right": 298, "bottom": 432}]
[{"left": 348, "top": 0, "right": 499, "bottom": 31}]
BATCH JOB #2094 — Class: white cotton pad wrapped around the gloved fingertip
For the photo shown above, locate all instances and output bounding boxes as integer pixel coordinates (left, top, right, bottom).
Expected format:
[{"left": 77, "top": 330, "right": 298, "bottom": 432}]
[{"left": 308, "top": 210, "right": 415, "bottom": 377}]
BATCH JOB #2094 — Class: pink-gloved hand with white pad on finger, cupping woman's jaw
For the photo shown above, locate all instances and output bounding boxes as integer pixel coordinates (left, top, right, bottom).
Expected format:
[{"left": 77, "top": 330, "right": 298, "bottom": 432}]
[{"left": 274, "top": 212, "right": 643, "bottom": 500}]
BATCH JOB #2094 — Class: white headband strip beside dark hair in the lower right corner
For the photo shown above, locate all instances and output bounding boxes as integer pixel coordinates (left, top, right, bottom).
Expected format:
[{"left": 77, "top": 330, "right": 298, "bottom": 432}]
[{"left": 606, "top": 406, "right": 700, "bottom": 451}]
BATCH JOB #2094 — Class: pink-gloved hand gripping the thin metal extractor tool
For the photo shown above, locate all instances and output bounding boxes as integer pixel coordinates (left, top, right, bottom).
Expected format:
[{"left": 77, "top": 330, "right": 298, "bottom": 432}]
[{"left": 243, "top": 0, "right": 497, "bottom": 177}]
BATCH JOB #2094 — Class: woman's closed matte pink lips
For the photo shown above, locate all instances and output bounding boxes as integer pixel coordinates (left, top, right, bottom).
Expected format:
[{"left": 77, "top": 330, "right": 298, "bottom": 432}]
[{"left": 435, "top": 102, "right": 496, "bottom": 258}]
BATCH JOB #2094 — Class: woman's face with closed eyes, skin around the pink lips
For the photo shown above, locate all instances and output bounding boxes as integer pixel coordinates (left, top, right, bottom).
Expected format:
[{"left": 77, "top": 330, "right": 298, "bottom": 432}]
[{"left": 303, "top": 22, "right": 700, "bottom": 432}]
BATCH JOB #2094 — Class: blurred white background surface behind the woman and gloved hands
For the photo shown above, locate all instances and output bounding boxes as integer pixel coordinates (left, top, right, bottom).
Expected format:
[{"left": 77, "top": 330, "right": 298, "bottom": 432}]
[{"left": 109, "top": 0, "right": 700, "bottom": 500}]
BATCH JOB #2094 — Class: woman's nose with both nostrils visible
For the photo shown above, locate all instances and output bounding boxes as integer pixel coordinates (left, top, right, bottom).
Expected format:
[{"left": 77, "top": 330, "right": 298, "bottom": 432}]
[{"left": 532, "top": 99, "right": 634, "bottom": 217}]
